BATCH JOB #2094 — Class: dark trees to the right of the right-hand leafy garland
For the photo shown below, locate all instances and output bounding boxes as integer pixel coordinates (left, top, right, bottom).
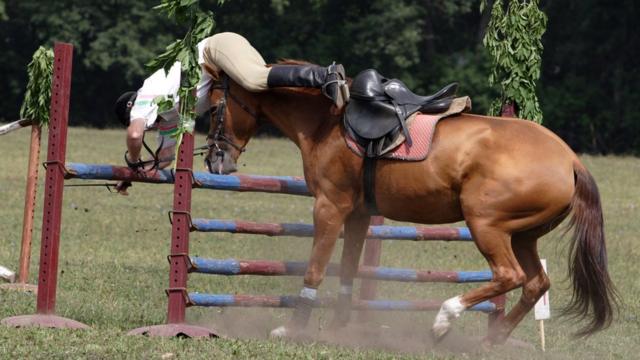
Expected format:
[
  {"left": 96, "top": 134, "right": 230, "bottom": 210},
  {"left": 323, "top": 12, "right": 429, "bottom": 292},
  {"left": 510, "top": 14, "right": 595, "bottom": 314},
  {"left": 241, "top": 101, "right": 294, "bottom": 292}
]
[{"left": 540, "top": 0, "right": 640, "bottom": 155}]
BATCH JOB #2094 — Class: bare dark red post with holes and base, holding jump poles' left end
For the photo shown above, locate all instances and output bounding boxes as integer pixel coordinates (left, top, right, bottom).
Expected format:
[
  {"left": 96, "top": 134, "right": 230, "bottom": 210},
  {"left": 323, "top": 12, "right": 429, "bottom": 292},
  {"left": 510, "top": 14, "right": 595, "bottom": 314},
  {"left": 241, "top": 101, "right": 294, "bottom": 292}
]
[{"left": 2, "top": 43, "right": 87, "bottom": 328}]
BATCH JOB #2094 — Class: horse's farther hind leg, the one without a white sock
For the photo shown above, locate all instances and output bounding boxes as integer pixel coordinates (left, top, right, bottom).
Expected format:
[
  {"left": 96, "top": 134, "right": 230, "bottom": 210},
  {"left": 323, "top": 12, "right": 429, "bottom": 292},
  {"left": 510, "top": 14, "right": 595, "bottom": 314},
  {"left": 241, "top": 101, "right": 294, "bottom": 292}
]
[{"left": 486, "top": 232, "right": 551, "bottom": 344}]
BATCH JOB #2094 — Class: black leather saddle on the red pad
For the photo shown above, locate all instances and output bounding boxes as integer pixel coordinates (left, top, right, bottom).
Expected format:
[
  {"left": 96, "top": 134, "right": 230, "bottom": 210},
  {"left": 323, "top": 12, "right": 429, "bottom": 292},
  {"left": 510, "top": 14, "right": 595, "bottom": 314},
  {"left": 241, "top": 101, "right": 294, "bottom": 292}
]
[{"left": 344, "top": 69, "right": 458, "bottom": 158}]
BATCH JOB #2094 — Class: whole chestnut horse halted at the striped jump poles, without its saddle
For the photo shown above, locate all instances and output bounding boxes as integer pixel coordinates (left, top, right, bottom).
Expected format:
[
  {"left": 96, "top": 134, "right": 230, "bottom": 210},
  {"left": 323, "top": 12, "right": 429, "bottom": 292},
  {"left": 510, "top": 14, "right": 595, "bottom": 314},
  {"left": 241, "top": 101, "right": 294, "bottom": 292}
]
[{"left": 205, "top": 65, "right": 616, "bottom": 344}]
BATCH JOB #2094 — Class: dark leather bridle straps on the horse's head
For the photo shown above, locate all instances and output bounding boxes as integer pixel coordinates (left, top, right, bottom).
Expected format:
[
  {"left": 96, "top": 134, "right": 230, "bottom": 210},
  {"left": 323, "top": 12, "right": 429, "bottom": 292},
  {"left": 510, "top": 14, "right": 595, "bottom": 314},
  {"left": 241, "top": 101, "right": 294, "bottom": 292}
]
[{"left": 205, "top": 74, "right": 260, "bottom": 167}]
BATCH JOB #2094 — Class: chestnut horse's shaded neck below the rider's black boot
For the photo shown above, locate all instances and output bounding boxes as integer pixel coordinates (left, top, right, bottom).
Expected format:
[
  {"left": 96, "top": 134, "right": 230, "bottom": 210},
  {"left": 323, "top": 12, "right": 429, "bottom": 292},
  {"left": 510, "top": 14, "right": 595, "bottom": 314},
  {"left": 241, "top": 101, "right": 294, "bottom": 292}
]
[{"left": 260, "top": 91, "right": 338, "bottom": 153}]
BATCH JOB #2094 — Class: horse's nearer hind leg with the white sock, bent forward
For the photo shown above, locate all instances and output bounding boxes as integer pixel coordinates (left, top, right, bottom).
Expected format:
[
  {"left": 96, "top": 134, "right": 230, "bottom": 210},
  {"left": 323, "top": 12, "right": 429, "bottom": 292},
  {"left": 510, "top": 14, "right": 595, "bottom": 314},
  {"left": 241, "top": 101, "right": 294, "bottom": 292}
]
[{"left": 432, "top": 224, "right": 525, "bottom": 339}]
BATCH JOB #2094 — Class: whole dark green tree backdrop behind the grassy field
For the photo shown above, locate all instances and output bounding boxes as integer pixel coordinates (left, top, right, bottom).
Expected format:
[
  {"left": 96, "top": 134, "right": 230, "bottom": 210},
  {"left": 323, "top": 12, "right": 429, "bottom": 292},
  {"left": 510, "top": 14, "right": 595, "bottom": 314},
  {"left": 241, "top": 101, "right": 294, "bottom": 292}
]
[{"left": 0, "top": 0, "right": 640, "bottom": 155}]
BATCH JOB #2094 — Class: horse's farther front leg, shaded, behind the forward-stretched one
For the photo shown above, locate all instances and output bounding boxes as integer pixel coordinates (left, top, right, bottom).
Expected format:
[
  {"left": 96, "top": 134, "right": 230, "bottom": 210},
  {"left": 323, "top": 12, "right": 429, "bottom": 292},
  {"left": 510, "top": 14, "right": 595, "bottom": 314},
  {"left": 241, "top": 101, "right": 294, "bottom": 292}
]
[{"left": 330, "top": 213, "right": 371, "bottom": 329}]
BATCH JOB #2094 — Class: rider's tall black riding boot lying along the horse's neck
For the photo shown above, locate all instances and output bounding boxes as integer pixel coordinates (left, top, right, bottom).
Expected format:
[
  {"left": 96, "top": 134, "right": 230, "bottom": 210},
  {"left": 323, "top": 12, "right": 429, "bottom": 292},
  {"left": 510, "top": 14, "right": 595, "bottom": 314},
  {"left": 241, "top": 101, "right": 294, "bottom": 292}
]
[{"left": 267, "top": 63, "right": 349, "bottom": 108}]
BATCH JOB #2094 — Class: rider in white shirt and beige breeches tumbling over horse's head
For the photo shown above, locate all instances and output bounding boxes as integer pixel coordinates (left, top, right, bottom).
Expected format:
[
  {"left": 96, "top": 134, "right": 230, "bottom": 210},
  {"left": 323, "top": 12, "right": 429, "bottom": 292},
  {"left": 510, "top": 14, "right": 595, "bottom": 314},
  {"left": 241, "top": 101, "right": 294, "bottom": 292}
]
[{"left": 115, "top": 32, "right": 348, "bottom": 194}]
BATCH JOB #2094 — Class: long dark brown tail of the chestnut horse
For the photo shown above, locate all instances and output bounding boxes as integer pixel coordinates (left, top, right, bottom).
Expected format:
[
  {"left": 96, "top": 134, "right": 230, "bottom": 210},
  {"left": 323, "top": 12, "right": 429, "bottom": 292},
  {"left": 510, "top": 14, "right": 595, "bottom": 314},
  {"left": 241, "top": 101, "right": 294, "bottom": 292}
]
[{"left": 564, "top": 160, "right": 618, "bottom": 337}]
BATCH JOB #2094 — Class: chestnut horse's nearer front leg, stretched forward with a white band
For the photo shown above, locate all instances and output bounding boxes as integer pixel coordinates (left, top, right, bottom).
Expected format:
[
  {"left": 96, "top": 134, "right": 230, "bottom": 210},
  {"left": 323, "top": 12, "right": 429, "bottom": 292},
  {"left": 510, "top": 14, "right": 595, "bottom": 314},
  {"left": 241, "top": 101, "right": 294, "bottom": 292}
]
[{"left": 271, "top": 196, "right": 350, "bottom": 337}]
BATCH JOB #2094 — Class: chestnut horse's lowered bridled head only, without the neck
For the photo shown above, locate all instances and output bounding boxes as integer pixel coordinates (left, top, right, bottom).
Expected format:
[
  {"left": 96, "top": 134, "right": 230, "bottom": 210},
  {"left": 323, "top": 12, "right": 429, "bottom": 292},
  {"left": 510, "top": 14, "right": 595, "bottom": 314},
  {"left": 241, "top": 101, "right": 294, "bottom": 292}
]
[{"left": 204, "top": 77, "right": 256, "bottom": 174}]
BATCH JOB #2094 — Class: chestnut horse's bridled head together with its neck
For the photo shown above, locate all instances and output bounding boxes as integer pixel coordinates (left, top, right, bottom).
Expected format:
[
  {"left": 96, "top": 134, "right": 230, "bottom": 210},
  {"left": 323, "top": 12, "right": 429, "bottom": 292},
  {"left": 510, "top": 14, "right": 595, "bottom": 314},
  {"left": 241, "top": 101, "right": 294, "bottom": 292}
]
[{"left": 204, "top": 60, "right": 339, "bottom": 174}]
